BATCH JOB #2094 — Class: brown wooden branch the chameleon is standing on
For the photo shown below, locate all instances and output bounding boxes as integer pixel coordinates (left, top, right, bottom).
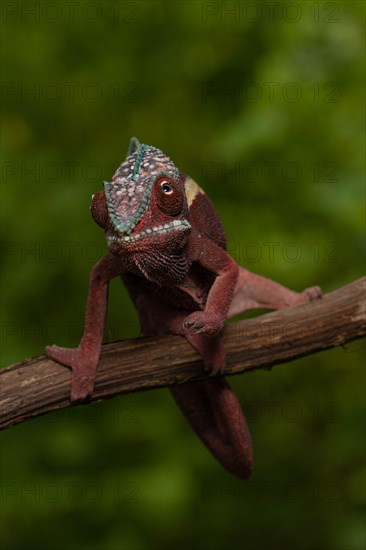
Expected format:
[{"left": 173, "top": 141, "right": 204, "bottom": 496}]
[{"left": 0, "top": 277, "right": 366, "bottom": 429}]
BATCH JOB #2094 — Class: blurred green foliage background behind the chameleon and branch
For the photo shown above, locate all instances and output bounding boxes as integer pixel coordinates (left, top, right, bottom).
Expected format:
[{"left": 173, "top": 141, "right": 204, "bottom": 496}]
[{"left": 1, "top": 0, "right": 365, "bottom": 550}]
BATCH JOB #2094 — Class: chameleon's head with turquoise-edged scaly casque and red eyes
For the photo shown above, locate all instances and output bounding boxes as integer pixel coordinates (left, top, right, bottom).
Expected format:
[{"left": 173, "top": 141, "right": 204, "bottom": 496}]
[{"left": 91, "top": 138, "right": 191, "bottom": 253}]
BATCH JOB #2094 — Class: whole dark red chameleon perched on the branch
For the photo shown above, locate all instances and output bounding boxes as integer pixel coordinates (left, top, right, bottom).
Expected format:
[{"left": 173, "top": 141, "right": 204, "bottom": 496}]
[{"left": 46, "top": 138, "right": 321, "bottom": 478}]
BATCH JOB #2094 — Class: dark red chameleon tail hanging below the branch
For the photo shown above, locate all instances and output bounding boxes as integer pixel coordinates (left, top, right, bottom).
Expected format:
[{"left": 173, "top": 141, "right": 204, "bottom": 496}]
[{"left": 170, "top": 377, "right": 253, "bottom": 479}]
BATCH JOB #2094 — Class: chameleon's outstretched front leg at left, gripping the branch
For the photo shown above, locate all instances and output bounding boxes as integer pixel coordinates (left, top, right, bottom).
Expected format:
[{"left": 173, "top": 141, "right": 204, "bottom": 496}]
[{"left": 45, "top": 254, "right": 120, "bottom": 401}]
